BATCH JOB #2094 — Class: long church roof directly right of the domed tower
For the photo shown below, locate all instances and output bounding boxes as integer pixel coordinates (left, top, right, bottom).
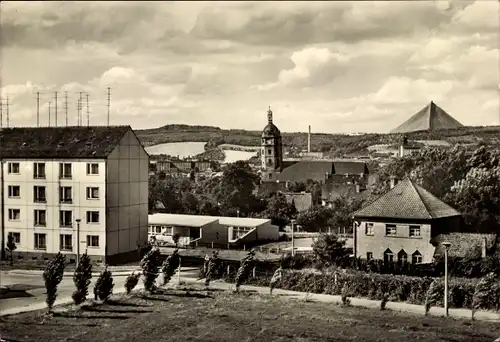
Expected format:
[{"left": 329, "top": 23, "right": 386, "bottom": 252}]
[{"left": 278, "top": 161, "right": 333, "bottom": 182}]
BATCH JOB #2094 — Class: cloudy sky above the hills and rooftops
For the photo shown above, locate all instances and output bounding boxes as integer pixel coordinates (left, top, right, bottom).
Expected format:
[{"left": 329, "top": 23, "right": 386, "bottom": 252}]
[{"left": 0, "top": 0, "right": 500, "bottom": 132}]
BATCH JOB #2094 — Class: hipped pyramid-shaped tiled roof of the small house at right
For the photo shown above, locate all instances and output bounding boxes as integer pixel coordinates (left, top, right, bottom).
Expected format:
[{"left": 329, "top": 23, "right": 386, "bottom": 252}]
[{"left": 353, "top": 179, "right": 460, "bottom": 220}]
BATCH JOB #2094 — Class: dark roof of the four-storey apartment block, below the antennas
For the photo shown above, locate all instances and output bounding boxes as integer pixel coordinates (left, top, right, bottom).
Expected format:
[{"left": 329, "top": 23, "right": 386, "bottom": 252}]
[{"left": 0, "top": 126, "right": 131, "bottom": 158}]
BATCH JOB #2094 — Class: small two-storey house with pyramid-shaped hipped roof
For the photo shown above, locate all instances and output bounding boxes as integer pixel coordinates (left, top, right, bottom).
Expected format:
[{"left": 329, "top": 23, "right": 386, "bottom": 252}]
[{"left": 353, "top": 179, "right": 461, "bottom": 264}]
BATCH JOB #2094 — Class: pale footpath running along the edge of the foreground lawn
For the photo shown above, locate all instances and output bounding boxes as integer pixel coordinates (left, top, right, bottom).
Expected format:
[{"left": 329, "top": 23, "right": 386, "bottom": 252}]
[{"left": 0, "top": 268, "right": 500, "bottom": 323}]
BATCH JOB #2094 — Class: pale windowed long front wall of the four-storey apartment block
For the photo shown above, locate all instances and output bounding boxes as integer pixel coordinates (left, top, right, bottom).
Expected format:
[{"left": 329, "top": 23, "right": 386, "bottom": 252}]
[{"left": 2, "top": 159, "right": 106, "bottom": 256}]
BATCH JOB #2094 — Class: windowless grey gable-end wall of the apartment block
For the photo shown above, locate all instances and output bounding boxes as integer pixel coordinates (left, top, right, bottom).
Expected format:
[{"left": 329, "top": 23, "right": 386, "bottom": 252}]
[{"left": 106, "top": 130, "right": 149, "bottom": 255}]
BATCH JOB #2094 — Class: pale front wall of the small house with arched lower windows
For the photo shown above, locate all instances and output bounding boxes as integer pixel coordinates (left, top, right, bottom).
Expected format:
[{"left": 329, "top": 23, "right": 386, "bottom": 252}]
[{"left": 356, "top": 220, "right": 434, "bottom": 263}]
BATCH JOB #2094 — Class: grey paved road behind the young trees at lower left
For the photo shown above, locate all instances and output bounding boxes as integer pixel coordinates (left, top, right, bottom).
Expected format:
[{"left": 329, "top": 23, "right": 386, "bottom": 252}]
[{"left": 0, "top": 267, "right": 198, "bottom": 312}]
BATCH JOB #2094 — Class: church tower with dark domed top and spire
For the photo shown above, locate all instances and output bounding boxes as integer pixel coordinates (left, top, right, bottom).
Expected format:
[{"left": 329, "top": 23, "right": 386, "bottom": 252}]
[{"left": 260, "top": 107, "right": 283, "bottom": 181}]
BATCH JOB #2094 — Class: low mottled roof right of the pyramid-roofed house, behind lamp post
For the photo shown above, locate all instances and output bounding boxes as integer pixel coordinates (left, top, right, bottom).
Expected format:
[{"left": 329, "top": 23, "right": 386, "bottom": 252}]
[{"left": 430, "top": 233, "right": 497, "bottom": 258}]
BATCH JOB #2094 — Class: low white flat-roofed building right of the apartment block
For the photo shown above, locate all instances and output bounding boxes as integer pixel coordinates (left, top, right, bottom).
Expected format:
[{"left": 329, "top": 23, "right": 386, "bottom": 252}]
[{"left": 149, "top": 214, "right": 279, "bottom": 248}]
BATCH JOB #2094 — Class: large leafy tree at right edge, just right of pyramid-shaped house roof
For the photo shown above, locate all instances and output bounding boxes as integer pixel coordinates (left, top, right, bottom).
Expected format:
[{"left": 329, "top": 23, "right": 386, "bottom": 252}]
[{"left": 445, "top": 166, "right": 500, "bottom": 232}]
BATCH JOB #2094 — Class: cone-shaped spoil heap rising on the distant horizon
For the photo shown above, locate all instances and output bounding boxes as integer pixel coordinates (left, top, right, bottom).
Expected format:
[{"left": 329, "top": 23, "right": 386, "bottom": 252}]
[{"left": 391, "top": 101, "right": 463, "bottom": 133}]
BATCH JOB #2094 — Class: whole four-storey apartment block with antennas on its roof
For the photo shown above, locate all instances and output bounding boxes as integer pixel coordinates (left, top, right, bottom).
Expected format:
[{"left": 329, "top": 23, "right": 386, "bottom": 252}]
[{"left": 0, "top": 126, "right": 149, "bottom": 264}]
